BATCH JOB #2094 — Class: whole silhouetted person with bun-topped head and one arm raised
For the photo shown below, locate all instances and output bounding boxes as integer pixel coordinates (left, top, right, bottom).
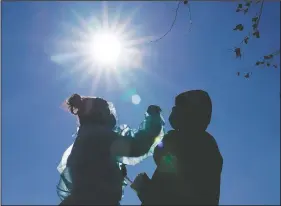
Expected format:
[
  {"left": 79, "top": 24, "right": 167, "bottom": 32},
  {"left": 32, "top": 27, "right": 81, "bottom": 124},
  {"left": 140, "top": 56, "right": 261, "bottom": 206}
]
[{"left": 57, "top": 94, "right": 164, "bottom": 205}]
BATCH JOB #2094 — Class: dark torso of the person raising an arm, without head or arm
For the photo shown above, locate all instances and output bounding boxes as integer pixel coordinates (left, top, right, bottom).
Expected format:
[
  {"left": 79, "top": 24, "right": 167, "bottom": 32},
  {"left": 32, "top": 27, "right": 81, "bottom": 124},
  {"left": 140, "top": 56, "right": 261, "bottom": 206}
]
[{"left": 68, "top": 124, "right": 123, "bottom": 202}]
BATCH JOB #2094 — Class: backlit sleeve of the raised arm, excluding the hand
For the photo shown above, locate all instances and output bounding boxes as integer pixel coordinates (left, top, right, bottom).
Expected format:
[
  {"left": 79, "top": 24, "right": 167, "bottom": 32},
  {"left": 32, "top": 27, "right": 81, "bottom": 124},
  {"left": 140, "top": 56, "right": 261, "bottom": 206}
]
[{"left": 111, "top": 113, "right": 165, "bottom": 165}]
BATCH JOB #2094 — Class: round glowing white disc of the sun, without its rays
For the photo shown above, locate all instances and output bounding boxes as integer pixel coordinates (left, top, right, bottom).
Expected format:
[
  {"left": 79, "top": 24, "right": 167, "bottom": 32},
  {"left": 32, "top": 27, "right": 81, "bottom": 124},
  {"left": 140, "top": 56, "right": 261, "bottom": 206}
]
[{"left": 90, "top": 32, "right": 122, "bottom": 65}]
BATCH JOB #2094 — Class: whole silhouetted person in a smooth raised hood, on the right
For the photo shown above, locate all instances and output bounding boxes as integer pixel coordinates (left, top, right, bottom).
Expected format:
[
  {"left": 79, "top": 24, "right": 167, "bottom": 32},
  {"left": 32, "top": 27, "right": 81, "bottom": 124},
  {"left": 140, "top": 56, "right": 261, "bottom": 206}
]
[{"left": 131, "top": 90, "right": 223, "bottom": 205}]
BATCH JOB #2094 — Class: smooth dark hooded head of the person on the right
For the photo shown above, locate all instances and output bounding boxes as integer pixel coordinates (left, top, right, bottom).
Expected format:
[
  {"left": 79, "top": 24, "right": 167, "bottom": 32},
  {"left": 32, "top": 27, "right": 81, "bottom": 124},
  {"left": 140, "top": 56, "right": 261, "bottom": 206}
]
[{"left": 169, "top": 90, "right": 212, "bottom": 131}]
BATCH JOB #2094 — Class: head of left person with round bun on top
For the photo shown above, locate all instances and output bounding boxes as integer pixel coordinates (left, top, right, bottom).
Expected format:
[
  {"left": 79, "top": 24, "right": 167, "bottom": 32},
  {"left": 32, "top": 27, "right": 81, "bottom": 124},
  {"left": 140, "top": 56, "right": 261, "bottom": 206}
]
[{"left": 66, "top": 94, "right": 117, "bottom": 128}]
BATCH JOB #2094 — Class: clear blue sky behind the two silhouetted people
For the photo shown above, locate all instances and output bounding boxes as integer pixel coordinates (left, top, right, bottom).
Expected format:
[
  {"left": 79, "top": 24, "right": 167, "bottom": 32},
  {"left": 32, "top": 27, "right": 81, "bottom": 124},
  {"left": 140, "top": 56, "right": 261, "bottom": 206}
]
[{"left": 2, "top": 2, "right": 280, "bottom": 204}]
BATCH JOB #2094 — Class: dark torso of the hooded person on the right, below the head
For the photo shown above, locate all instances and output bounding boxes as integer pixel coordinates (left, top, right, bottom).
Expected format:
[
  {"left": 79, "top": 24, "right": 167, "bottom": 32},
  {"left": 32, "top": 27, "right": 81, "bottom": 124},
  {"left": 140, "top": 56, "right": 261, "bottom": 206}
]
[{"left": 148, "top": 131, "right": 222, "bottom": 204}]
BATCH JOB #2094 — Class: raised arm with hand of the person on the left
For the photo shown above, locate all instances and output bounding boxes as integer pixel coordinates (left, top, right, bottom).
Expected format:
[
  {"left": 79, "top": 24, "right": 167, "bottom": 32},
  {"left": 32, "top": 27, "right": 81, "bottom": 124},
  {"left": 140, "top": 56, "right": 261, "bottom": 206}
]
[{"left": 111, "top": 105, "right": 164, "bottom": 157}]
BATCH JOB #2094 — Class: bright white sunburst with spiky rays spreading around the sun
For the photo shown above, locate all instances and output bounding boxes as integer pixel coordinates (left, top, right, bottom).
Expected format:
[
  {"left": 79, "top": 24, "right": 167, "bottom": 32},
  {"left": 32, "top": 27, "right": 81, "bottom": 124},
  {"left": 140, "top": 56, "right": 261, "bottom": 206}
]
[{"left": 51, "top": 3, "right": 152, "bottom": 92}]
